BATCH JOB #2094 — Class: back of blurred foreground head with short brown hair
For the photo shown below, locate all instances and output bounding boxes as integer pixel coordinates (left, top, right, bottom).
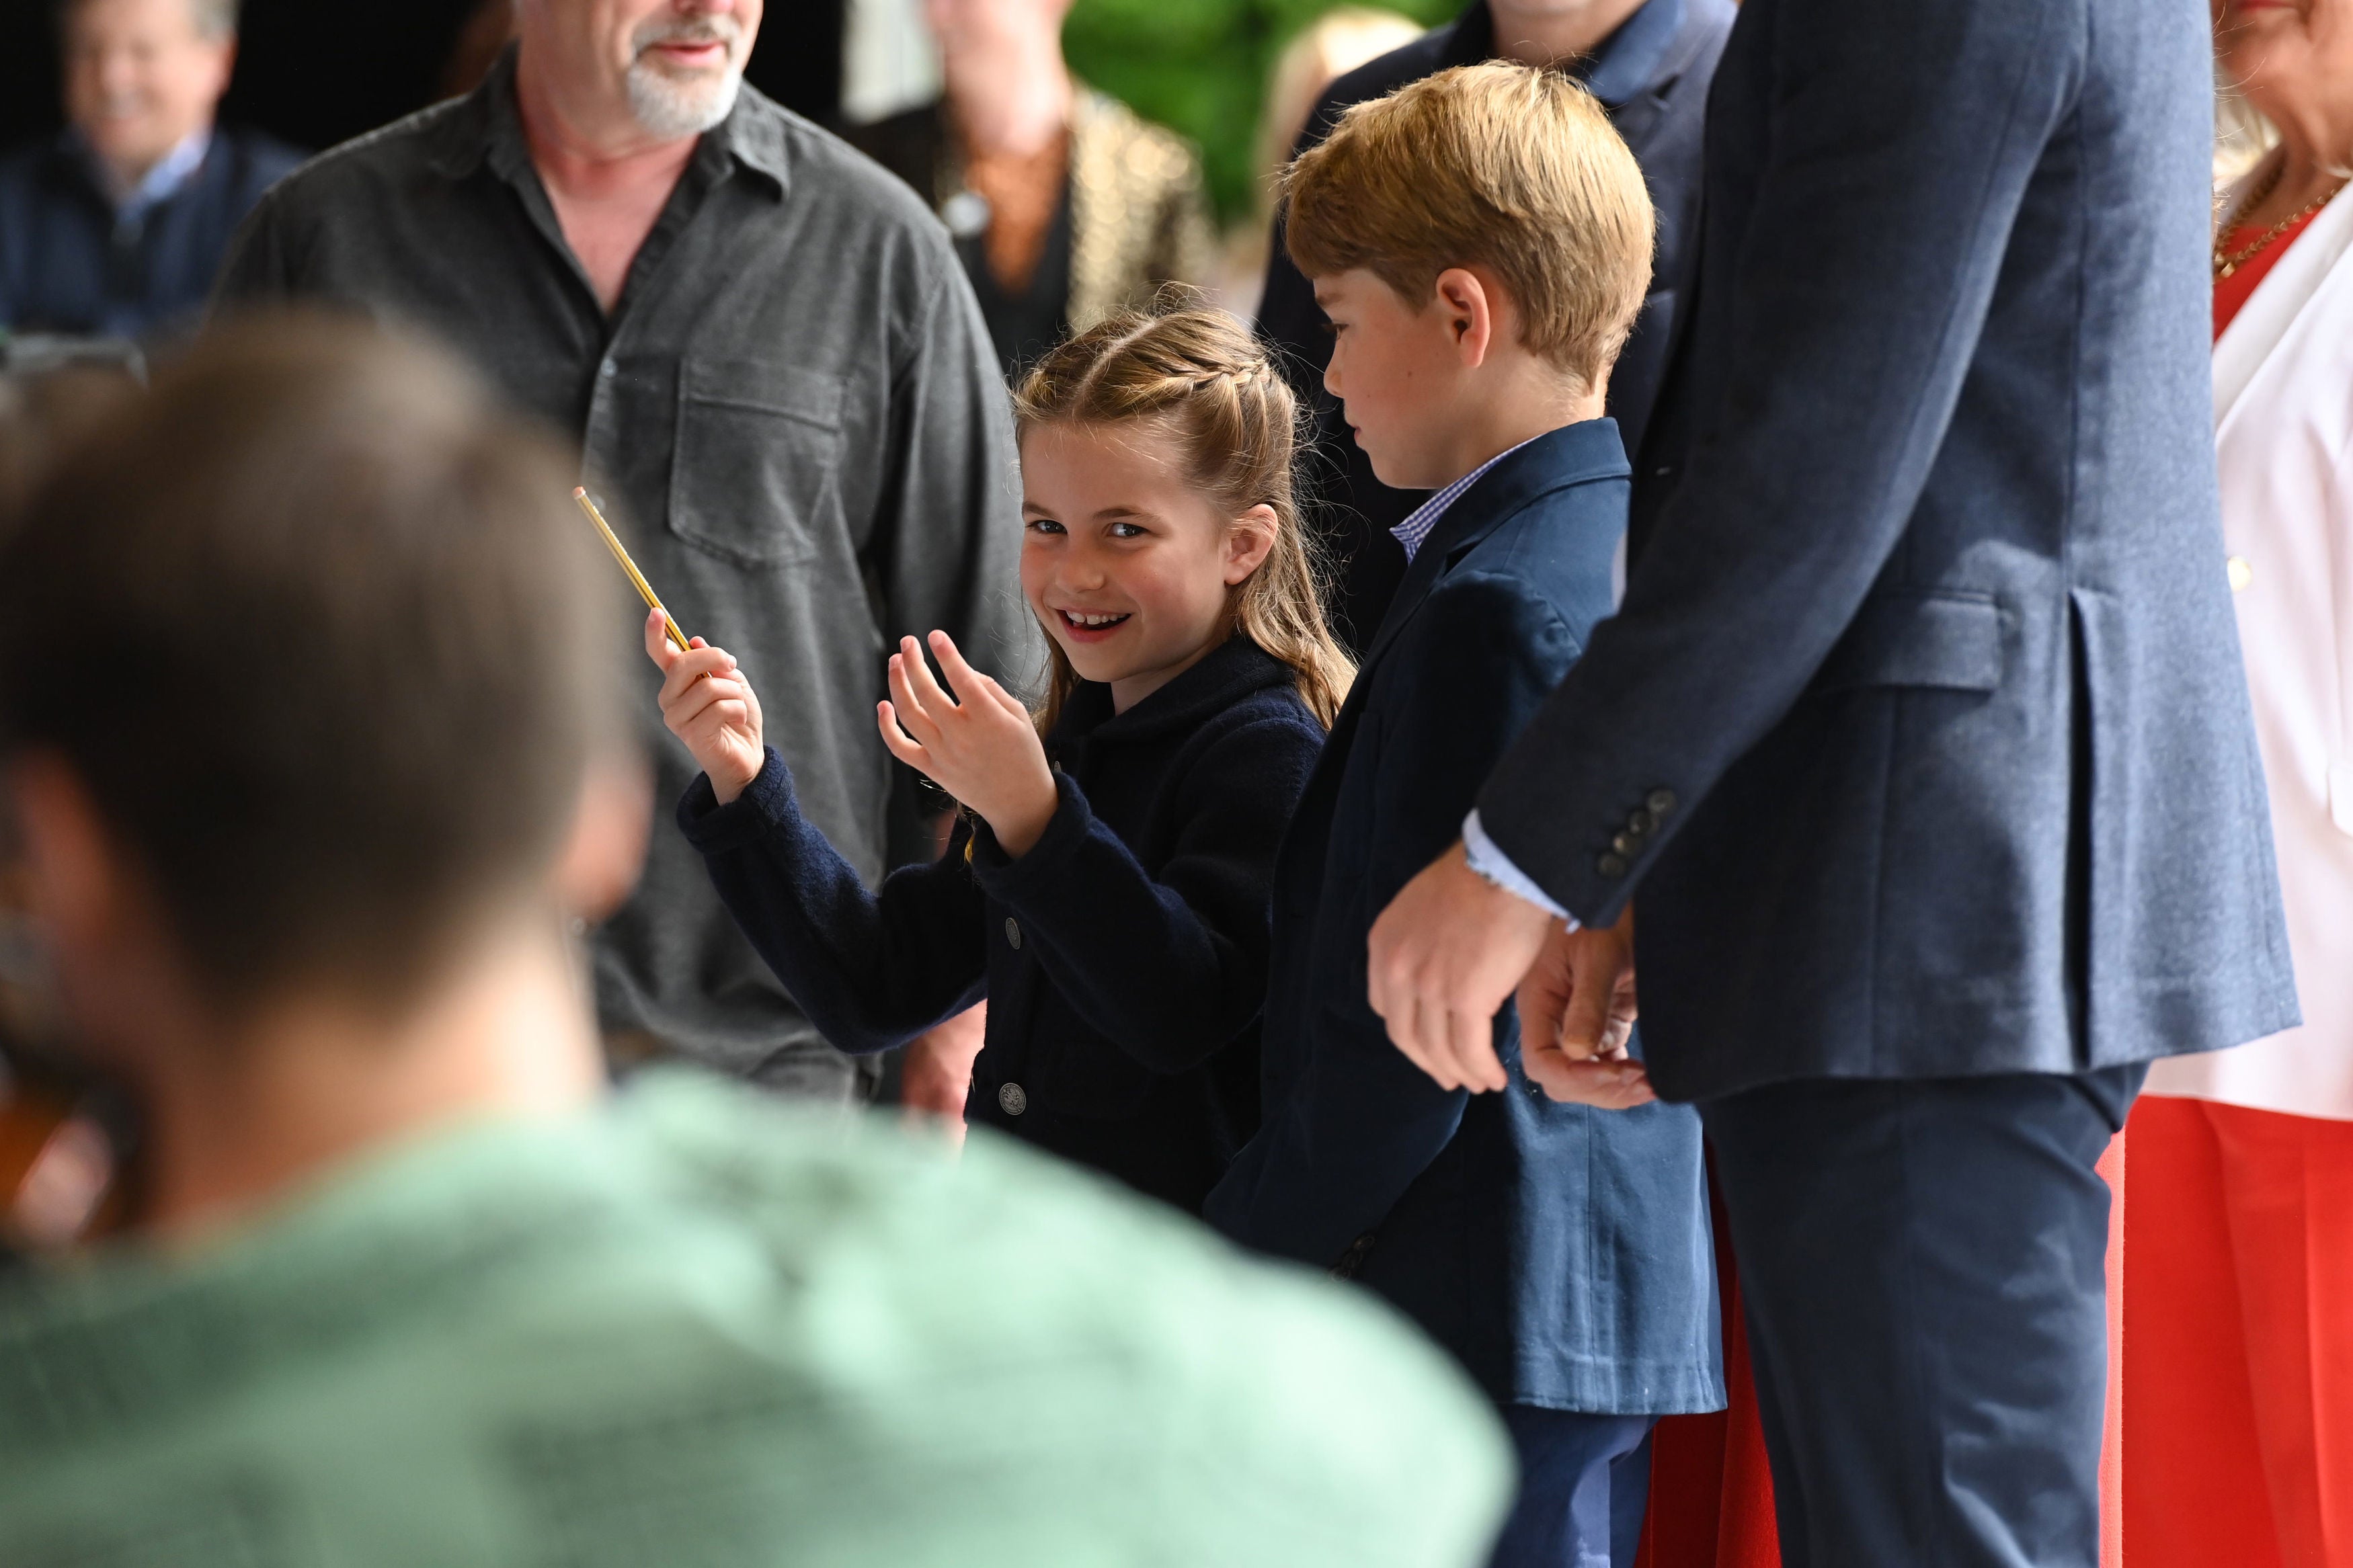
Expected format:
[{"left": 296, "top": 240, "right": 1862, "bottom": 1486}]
[{"left": 0, "top": 320, "right": 643, "bottom": 1222}]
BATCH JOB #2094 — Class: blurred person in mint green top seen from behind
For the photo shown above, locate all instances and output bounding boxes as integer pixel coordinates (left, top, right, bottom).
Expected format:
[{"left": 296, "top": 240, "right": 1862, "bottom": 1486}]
[{"left": 0, "top": 322, "right": 1509, "bottom": 1568}]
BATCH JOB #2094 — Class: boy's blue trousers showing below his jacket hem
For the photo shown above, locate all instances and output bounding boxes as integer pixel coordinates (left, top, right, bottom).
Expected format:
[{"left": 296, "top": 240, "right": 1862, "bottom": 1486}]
[{"left": 1490, "top": 1406, "right": 1659, "bottom": 1568}]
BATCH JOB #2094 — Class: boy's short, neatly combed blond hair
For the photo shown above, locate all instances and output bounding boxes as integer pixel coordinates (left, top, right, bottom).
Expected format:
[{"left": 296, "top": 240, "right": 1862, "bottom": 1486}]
[{"left": 1283, "top": 61, "right": 1657, "bottom": 388}]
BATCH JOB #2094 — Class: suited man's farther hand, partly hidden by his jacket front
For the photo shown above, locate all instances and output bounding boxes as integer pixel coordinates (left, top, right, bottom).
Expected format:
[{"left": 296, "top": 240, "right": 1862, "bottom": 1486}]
[{"left": 1520, "top": 905, "right": 1657, "bottom": 1110}]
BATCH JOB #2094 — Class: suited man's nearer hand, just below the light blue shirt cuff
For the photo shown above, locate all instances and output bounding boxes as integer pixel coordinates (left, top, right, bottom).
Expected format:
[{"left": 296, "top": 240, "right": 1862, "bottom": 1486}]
[{"left": 1367, "top": 841, "right": 1553, "bottom": 1091}]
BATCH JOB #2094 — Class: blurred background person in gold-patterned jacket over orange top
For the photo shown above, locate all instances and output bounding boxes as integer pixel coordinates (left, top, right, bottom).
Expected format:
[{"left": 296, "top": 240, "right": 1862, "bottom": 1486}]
[{"left": 845, "top": 0, "right": 1217, "bottom": 376}]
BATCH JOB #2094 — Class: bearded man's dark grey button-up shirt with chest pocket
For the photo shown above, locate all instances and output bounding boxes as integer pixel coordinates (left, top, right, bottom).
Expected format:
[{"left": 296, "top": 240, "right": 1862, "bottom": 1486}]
[{"left": 216, "top": 52, "right": 1038, "bottom": 1079}]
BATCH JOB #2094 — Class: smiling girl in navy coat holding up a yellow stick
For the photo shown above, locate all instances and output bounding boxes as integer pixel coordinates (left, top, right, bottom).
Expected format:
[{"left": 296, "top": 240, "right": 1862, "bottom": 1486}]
[{"left": 664, "top": 311, "right": 1353, "bottom": 1208}]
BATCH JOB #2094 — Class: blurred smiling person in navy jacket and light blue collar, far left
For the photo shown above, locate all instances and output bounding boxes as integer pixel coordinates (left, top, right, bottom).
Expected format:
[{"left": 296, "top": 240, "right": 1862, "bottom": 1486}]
[{"left": 0, "top": 0, "right": 301, "bottom": 339}]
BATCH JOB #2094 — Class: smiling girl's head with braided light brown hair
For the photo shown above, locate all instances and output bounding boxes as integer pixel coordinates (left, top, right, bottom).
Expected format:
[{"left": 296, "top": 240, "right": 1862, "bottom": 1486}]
[{"left": 1014, "top": 308, "right": 1355, "bottom": 729}]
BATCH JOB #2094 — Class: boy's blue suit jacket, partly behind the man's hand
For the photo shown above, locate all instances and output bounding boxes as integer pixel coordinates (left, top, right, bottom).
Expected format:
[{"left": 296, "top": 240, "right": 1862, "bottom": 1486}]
[{"left": 1205, "top": 419, "right": 1722, "bottom": 1415}]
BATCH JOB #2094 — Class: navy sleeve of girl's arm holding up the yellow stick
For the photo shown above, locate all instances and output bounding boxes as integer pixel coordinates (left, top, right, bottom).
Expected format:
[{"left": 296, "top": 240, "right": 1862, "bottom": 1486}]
[{"left": 678, "top": 747, "right": 988, "bottom": 1053}]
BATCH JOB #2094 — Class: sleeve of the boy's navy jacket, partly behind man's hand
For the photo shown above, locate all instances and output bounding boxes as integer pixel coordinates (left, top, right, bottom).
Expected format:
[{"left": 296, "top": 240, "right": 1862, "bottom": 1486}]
[{"left": 1205, "top": 576, "right": 1577, "bottom": 1265}]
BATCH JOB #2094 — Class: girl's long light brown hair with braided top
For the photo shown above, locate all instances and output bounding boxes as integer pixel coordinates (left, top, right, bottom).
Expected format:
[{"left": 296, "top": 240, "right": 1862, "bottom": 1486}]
[{"left": 1014, "top": 298, "right": 1355, "bottom": 733}]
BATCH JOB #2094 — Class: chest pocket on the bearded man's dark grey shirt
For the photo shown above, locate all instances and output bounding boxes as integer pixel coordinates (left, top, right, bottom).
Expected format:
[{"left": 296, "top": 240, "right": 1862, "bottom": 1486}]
[{"left": 671, "top": 358, "right": 847, "bottom": 571}]
